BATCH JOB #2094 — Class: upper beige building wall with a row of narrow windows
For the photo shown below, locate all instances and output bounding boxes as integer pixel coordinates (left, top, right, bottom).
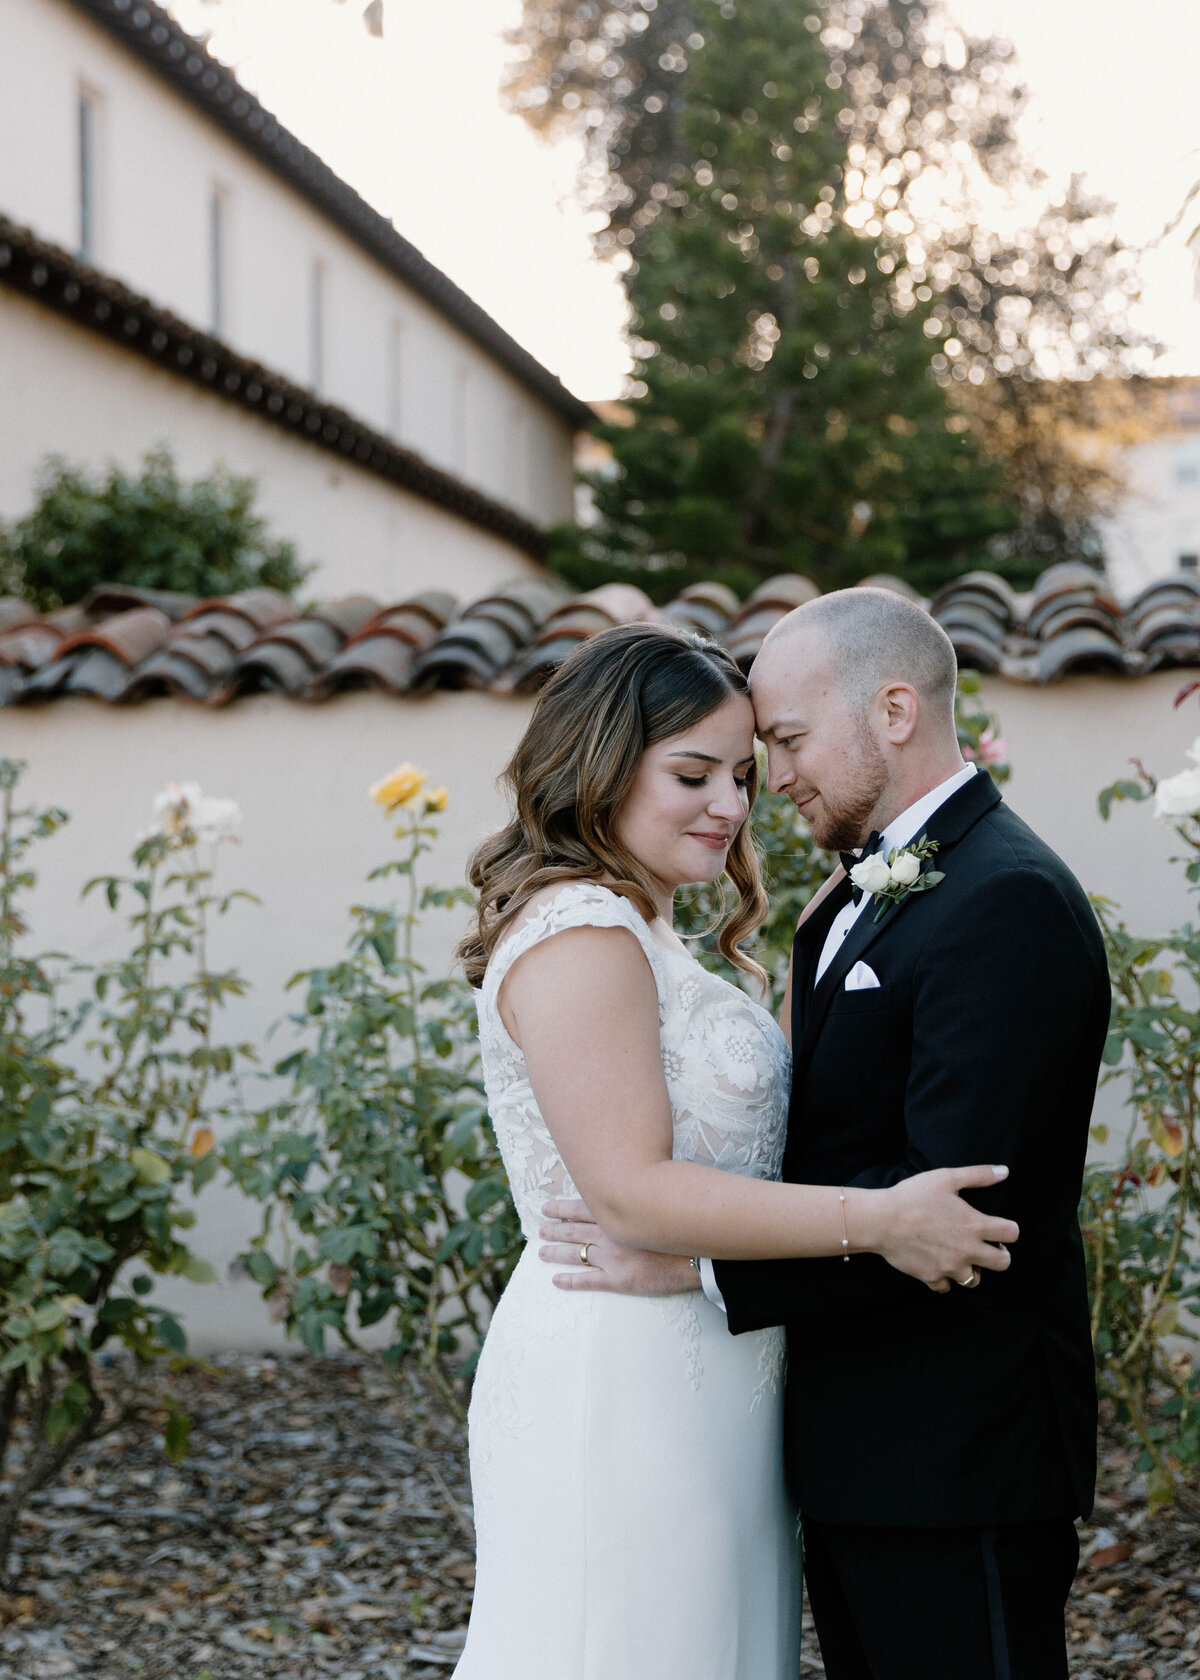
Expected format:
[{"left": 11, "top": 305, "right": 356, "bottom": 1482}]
[{"left": 0, "top": 0, "right": 573, "bottom": 527}]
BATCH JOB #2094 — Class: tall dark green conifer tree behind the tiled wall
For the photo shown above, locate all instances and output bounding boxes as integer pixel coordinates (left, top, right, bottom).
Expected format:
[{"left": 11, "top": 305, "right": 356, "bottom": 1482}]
[{"left": 547, "top": 0, "right": 1017, "bottom": 593}]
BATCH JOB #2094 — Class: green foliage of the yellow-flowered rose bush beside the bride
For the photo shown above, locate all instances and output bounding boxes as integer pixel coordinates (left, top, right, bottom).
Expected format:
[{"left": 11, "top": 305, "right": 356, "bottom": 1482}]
[{"left": 225, "top": 813, "right": 521, "bottom": 1371}]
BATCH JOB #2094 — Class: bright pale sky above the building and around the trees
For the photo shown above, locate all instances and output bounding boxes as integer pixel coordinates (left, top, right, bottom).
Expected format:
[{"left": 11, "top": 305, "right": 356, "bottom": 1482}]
[{"left": 171, "top": 0, "right": 1200, "bottom": 398}]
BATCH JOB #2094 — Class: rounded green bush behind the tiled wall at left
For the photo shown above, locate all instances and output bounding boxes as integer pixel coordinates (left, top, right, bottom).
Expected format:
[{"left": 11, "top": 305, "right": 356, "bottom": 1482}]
[{"left": 0, "top": 450, "right": 308, "bottom": 612}]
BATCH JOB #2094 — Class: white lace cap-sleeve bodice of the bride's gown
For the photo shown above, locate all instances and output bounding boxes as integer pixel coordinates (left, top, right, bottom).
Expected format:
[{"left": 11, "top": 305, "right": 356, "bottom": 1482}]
[{"left": 479, "top": 882, "right": 790, "bottom": 1236}]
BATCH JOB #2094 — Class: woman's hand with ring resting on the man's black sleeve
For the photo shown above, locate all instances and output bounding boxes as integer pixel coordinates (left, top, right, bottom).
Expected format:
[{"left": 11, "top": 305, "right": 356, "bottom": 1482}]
[{"left": 872, "top": 1166, "right": 1020, "bottom": 1295}]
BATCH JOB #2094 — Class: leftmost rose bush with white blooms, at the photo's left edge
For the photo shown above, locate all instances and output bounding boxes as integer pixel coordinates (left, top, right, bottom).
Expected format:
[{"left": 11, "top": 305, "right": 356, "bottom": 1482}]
[{"left": 0, "top": 759, "right": 252, "bottom": 1569}]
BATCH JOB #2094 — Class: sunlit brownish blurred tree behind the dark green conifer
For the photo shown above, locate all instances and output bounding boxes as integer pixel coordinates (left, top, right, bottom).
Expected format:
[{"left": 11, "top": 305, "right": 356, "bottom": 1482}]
[{"left": 508, "top": 0, "right": 1153, "bottom": 580}]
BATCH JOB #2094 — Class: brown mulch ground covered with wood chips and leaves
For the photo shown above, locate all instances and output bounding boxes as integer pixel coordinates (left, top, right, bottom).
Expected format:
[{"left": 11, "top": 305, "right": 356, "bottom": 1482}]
[{"left": 0, "top": 1356, "right": 1200, "bottom": 1680}]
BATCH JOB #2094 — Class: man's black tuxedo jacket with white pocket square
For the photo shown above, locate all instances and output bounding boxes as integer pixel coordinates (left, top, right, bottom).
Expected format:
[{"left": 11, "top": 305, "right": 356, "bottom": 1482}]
[{"left": 705, "top": 773, "right": 1109, "bottom": 1527}]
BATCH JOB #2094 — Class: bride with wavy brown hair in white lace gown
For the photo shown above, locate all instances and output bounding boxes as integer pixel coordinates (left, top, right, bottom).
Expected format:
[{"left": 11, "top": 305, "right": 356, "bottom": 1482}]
[{"left": 455, "top": 625, "right": 1017, "bottom": 1680}]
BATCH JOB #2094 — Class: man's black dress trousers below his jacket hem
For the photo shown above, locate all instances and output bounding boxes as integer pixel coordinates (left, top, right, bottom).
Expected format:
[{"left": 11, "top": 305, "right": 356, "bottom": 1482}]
[{"left": 803, "top": 1517, "right": 1079, "bottom": 1680}]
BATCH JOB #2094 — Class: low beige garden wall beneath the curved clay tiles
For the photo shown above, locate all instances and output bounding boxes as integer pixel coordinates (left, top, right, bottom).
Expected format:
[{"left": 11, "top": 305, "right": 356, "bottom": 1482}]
[{"left": 0, "top": 674, "right": 1200, "bottom": 1349}]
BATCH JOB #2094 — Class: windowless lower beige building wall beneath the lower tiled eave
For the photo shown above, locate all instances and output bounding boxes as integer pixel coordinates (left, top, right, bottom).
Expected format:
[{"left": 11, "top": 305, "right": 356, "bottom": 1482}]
[{"left": 0, "top": 287, "right": 545, "bottom": 604}]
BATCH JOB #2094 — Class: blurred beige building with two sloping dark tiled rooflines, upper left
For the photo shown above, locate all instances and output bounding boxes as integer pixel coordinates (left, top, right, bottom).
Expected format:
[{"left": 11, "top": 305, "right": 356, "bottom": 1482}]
[{"left": 0, "top": 0, "right": 590, "bottom": 600}]
